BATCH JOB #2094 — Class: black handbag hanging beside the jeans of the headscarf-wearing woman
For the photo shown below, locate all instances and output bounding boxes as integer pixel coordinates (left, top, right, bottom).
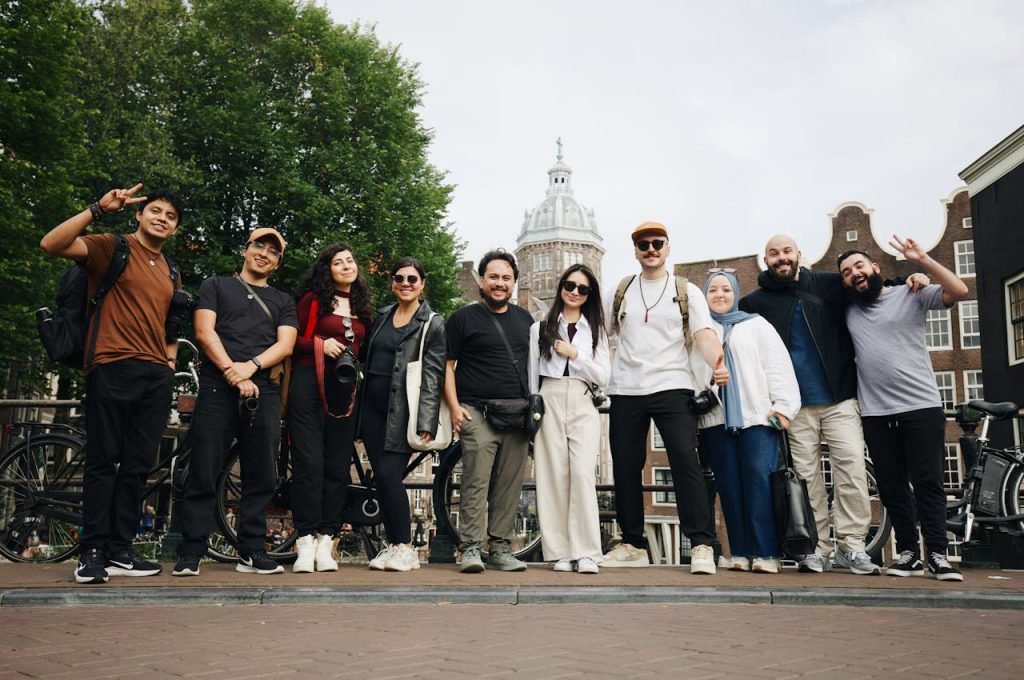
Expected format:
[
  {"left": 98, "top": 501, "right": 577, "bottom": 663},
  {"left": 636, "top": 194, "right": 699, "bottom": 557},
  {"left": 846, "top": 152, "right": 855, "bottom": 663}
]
[{"left": 770, "top": 431, "right": 818, "bottom": 559}]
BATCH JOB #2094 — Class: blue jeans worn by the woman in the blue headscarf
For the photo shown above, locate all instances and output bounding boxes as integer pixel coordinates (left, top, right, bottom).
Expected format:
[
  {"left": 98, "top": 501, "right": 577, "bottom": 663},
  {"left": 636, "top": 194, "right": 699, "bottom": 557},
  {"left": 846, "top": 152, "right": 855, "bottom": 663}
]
[{"left": 700, "top": 425, "right": 782, "bottom": 557}]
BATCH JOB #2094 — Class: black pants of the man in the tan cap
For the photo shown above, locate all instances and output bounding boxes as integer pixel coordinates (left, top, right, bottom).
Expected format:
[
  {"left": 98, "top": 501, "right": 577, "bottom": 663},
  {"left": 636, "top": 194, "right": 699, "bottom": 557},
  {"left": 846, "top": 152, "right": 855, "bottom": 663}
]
[{"left": 178, "top": 387, "right": 281, "bottom": 555}]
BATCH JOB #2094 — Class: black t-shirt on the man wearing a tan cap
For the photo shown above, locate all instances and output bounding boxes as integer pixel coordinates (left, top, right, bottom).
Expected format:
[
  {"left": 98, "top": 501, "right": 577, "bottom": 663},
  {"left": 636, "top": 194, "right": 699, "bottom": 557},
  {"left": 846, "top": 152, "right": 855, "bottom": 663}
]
[{"left": 198, "top": 277, "right": 299, "bottom": 389}]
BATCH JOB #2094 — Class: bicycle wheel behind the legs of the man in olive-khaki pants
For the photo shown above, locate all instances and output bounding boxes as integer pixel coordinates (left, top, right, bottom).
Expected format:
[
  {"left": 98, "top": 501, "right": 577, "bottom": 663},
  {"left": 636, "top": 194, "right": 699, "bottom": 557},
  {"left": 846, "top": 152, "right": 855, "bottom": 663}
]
[{"left": 431, "top": 441, "right": 541, "bottom": 560}]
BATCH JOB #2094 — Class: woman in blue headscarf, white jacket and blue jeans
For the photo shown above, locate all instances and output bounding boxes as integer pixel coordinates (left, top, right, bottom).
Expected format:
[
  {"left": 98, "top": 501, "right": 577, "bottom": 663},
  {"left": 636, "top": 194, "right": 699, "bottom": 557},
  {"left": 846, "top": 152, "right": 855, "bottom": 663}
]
[{"left": 691, "top": 269, "right": 800, "bottom": 573}]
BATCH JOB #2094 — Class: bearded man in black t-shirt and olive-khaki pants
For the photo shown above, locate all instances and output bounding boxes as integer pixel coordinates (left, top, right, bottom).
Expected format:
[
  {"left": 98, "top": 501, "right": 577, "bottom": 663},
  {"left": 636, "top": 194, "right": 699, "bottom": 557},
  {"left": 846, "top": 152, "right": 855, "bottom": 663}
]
[{"left": 444, "top": 250, "right": 534, "bottom": 573}]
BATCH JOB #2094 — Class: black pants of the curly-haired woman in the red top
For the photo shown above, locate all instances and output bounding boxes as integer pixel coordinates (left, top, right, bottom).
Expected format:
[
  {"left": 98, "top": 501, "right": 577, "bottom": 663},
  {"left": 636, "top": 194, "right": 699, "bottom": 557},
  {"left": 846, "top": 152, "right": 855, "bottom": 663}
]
[{"left": 288, "top": 364, "right": 355, "bottom": 537}]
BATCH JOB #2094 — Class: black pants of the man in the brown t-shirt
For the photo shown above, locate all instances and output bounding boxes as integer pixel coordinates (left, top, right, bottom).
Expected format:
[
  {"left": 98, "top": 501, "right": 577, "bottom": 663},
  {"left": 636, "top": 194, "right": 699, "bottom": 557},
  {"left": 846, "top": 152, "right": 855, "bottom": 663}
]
[{"left": 80, "top": 359, "right": 174, "bottom": 553}]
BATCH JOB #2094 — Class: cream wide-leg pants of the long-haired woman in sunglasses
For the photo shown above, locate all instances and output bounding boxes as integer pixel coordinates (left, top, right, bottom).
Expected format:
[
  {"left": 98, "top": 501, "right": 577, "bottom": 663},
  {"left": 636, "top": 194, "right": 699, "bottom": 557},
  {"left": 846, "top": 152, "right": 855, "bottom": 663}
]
[{"left": 534, "top": 378, "right": 601, "bottom": 562}]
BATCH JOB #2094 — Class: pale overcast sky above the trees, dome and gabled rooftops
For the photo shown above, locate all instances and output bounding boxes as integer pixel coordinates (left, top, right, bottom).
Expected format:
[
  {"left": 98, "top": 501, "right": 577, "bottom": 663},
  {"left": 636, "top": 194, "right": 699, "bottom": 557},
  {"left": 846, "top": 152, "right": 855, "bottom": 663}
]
[{"left": 326, "top": 0, "right": 1024, "bottom": 287}]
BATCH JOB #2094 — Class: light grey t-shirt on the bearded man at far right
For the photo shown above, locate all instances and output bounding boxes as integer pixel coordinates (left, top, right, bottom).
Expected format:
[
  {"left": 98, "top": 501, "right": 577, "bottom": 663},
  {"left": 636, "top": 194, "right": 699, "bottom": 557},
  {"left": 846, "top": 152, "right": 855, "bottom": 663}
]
[{"left": 846, "top": 284, "right": 946, "bottom": 416}]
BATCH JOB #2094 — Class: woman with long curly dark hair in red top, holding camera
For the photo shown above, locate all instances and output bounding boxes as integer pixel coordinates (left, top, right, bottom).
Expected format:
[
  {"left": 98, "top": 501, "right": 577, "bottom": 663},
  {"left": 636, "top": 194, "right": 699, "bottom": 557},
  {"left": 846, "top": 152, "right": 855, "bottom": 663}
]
[{"left": 288, "top": 243, "right": 372, "bottom": 572}]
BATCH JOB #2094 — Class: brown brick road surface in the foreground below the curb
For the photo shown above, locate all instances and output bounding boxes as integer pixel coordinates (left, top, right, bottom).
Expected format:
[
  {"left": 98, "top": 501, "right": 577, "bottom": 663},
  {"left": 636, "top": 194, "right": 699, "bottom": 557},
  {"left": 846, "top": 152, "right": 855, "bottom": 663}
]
[{"left": 0, "top": 605, "right": 1024, "bottom": 680}]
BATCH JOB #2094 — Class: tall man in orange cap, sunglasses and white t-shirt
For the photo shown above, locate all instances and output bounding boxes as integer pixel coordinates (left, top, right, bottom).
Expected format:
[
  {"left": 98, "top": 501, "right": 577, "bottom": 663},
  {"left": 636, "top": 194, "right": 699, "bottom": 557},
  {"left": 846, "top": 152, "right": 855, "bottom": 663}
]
[{"left": 603, "top": 222, "right": 729, "bottom": 573}]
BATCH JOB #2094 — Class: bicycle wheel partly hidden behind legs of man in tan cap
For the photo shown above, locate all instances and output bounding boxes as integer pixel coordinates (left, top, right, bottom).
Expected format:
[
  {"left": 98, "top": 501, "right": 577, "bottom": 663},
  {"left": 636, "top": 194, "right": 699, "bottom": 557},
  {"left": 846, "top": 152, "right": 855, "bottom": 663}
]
[{"left": 215, "top": 445, "right": 297, "bottom": 563}]
